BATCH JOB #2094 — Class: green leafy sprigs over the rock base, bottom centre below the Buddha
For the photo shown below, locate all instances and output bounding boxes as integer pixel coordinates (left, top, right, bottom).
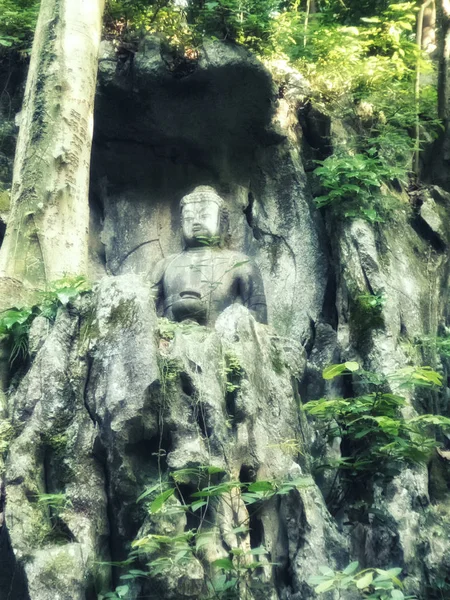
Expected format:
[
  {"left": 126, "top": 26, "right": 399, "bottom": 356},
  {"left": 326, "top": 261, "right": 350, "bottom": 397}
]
[{"left": 99, "top": 465, "right": 312, "bottom": 600}]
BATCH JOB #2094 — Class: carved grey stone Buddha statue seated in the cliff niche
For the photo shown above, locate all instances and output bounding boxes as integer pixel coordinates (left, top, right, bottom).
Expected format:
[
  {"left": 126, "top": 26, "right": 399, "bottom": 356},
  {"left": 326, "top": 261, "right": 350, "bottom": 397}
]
[{"left": 153, "top": 186, "right": 267, "bottom": 325}]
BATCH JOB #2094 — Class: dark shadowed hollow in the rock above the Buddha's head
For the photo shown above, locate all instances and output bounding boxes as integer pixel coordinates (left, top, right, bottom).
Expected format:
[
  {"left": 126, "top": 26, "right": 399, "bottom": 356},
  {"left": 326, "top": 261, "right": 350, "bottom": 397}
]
[{"left": 88, "top": 39, "right": 280, "bottom": 220}]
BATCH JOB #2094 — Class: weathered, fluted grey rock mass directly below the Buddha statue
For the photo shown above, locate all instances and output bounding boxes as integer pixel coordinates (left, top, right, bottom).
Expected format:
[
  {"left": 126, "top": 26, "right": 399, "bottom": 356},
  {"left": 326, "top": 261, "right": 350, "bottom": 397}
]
[{"left": 1, "top": 275, "right": 346, "bottom": 600}]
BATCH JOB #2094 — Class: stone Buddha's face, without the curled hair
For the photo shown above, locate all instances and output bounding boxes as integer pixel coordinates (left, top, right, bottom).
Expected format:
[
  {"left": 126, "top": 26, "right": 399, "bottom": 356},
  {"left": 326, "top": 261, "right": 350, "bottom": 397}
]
[{"left": 181, "top": 200, "right": 220, "bottom": 246}]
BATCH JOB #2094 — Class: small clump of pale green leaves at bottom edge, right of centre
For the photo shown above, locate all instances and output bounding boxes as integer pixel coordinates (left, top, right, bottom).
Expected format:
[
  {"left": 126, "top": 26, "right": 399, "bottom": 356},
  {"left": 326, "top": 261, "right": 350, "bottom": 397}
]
[{"left": 308, "top": 562, "right": 415, "bottom": 600}]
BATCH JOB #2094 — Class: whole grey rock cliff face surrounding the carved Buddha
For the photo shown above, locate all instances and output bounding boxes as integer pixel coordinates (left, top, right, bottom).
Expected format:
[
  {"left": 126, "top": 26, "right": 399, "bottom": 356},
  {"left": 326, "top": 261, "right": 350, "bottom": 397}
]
[{"left": 0, "top": 38, "right": 450, "bottom": 600}]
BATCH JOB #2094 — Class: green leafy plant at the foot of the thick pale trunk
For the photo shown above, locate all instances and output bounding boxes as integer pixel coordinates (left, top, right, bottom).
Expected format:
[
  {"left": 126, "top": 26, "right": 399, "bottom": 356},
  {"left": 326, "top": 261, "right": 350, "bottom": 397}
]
[{"left": 0, "top": 275, "right": 90, "bottom": 364}]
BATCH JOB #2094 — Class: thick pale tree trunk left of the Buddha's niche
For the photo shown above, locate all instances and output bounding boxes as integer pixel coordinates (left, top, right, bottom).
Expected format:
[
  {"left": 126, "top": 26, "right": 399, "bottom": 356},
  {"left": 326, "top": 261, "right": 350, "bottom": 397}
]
[{"left": 0, "top": 0, "right": 104, "bottom": 288}]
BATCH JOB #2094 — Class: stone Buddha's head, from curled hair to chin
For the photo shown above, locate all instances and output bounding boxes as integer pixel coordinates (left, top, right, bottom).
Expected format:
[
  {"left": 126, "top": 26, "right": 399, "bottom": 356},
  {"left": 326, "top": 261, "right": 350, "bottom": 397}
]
[{"left": 180, "top": 185, "right": 228, "bottom": 246}]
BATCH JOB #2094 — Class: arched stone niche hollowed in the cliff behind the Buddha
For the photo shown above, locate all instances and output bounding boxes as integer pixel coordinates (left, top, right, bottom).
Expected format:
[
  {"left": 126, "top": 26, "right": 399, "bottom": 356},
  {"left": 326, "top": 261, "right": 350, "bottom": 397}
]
[{"left": 91, "top": 38, "right": 326, "bottom": 339}]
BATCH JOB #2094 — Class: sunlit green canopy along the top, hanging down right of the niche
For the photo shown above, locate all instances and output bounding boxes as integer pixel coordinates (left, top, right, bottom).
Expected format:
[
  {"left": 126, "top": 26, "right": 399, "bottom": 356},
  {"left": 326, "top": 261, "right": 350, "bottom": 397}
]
[{"left": 0, "top": 0, "right": 441, "bottom": 220}]
